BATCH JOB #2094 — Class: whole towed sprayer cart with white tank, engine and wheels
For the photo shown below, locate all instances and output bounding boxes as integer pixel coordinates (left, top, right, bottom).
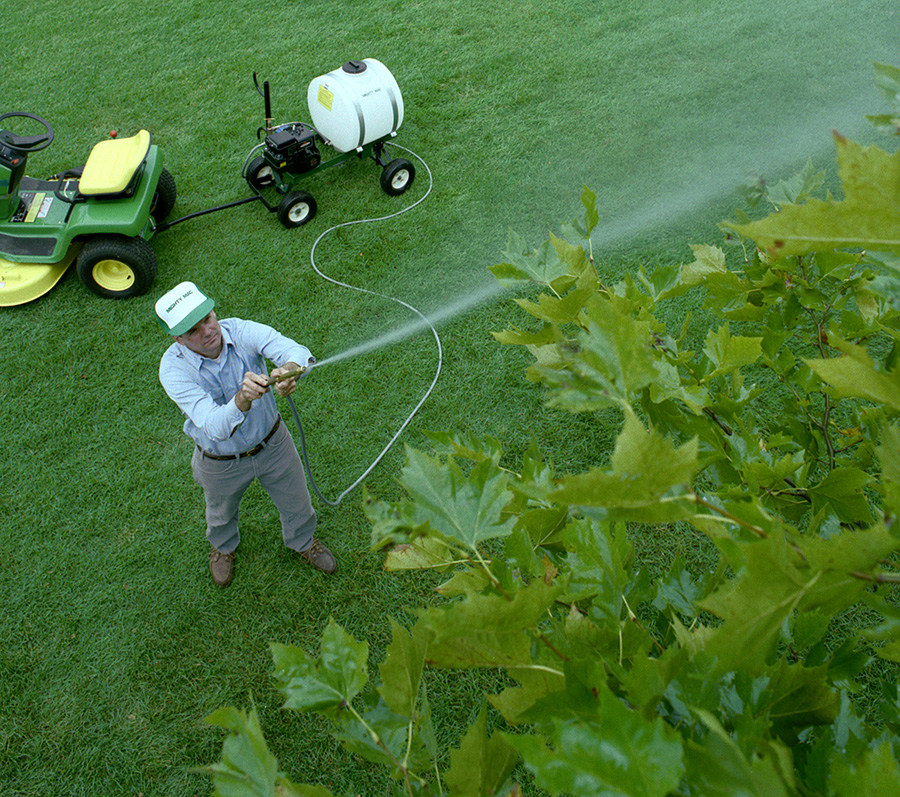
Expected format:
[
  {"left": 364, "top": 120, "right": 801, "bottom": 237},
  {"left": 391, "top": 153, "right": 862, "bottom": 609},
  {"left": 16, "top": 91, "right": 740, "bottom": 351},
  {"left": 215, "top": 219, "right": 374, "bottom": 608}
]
[{"left": 242, "top": 58, "right": 416, "bottom": 227}]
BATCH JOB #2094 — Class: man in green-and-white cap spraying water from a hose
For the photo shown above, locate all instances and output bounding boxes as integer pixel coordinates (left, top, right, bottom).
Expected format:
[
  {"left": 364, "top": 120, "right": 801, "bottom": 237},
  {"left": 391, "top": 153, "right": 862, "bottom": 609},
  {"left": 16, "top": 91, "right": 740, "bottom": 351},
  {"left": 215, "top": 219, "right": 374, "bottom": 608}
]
[{"left": 156, "top": 282, "right": 337, "bottom": 587}]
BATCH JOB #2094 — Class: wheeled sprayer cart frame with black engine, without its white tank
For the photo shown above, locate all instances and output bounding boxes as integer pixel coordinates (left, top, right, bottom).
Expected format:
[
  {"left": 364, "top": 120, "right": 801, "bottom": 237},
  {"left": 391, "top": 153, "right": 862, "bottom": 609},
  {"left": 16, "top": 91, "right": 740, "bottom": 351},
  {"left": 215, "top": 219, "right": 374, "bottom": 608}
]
[{"left": 241, "top": 72, "right": 416, "bottom": 228}]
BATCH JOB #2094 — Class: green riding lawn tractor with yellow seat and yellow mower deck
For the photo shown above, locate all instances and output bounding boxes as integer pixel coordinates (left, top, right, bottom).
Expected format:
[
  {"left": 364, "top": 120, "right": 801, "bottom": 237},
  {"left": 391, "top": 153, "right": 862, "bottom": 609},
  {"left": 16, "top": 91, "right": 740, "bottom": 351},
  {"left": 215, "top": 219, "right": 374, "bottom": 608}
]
[{"left": 0, "top": 112, "right": 175, "bottom": 307}]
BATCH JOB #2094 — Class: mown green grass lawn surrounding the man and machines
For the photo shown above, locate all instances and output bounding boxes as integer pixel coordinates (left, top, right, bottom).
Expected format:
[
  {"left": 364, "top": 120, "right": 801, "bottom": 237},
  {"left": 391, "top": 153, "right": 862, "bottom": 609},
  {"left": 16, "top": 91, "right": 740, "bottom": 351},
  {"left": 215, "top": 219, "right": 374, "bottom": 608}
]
[{"left": 0, "top": 0, "right": 900, "bottom": 797}]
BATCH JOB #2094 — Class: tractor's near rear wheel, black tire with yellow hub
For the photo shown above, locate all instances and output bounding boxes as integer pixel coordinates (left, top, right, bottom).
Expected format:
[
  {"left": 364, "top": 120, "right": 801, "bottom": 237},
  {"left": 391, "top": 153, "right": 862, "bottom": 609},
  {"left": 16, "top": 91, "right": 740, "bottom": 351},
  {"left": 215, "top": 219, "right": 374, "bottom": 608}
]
[{"left": 75, "top": 235, "right": 156, "bottom": 299}]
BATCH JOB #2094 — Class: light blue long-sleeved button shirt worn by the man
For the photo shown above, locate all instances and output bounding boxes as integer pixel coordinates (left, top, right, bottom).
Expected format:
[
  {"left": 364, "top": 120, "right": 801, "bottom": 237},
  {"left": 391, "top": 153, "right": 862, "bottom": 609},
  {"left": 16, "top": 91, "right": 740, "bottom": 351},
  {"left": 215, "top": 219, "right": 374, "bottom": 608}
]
[{"left": 159, "top": 318, "right": 312, "bottom": 454}]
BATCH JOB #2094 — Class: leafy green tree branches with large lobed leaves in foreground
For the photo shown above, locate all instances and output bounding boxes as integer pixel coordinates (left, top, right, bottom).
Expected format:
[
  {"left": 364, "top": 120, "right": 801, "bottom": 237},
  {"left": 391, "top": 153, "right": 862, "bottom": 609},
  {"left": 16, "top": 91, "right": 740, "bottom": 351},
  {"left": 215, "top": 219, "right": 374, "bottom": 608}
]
[{"left": 204, "top": 93, "right": 900, "bottom": 797}]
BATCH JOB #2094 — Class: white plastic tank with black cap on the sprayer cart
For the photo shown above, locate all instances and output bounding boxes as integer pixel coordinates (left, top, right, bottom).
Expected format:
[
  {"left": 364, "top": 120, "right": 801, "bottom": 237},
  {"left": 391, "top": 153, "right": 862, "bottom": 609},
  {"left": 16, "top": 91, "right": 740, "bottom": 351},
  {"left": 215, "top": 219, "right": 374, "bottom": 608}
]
[{"left": 306, "top": 58, "right": 403, "bottom": 152}]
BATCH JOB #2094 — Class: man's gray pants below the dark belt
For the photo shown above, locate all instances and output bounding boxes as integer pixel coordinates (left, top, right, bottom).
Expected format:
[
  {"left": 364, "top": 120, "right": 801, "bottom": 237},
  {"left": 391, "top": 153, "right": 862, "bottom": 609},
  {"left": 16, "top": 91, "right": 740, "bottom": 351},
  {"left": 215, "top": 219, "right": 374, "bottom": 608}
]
[{"left": 191, "top": 422, "right": 316, "bottom": 553}]
